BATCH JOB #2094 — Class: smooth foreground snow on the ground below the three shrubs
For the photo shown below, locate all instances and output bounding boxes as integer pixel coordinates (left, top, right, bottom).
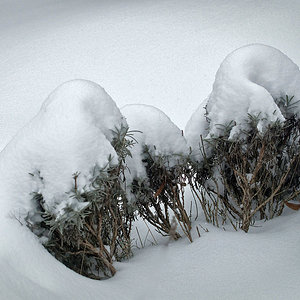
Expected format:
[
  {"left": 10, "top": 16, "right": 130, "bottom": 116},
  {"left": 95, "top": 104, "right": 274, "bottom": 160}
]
[{"left": 0, "top": 213, "right": 300, "bottom": 300}]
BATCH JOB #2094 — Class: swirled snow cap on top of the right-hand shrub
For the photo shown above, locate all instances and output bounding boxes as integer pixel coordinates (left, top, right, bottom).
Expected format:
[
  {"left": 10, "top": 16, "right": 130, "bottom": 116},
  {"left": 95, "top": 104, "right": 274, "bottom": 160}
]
[{"left": 185, "top": 44, "right": 300, "bottom": 152}]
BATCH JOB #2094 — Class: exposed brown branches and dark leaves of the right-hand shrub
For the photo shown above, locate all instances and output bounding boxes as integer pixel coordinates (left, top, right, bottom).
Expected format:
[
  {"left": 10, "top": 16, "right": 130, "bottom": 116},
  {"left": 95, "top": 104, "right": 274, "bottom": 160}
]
[{"left": 191, "top": 110, "right": 300, "bottom": 232}]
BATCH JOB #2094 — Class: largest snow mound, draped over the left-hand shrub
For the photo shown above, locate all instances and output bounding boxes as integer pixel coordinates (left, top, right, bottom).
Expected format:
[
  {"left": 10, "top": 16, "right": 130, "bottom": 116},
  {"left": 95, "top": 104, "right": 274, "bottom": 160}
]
[{"left": 0, "top": 80, "right": 126, "bottom": 214}]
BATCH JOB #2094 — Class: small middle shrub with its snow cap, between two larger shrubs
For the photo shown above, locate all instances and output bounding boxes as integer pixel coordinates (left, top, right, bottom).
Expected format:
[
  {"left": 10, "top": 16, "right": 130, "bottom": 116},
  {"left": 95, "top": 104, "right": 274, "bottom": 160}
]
[{"left": 121, "top": 104, "right": 192, "bottom": 240}]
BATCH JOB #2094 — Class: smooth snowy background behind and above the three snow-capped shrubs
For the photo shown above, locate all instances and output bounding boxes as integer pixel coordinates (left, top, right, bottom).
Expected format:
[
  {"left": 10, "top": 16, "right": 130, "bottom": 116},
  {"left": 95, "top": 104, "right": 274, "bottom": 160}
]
[{"left": 0, "top": 0, "right": 300, "bottom": 148}]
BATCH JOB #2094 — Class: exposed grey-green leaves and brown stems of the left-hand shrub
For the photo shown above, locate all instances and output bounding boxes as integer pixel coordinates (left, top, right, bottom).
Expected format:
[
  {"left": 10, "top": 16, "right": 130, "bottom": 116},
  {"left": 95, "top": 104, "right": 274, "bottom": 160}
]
[{"left": 27, "top": 126, "right": 135, "bottom": 279}]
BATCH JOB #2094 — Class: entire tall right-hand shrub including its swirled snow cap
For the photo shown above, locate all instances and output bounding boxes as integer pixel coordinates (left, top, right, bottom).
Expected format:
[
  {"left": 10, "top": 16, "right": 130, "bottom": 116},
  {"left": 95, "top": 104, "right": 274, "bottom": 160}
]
[{"left": 186, "top": 45, "right": 300, "bottom": 231}]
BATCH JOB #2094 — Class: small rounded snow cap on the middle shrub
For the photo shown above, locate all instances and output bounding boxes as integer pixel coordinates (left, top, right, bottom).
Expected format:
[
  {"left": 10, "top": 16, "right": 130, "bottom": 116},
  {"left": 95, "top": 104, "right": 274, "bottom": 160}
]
[{"left": 121, "top": 104, "right": 188, "bottom": 182}]
